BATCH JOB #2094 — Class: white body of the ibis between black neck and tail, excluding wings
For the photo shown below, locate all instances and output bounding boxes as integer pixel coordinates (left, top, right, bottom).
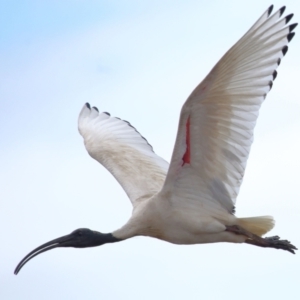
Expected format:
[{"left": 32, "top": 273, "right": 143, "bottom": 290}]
[{"left": 112, "top": 194, "right": 241, "bottom": 244}]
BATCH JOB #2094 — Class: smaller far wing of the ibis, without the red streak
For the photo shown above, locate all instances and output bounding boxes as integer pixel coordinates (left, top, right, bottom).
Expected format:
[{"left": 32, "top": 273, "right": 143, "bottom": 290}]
[{"left": 78, "top": 103, "right": 169, "bottom": 206}]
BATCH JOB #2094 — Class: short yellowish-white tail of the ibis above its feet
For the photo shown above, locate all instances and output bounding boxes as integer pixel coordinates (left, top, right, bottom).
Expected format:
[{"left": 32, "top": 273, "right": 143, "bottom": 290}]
[{"left": 238, "top": 216, "right": 275, "bottom": 236}]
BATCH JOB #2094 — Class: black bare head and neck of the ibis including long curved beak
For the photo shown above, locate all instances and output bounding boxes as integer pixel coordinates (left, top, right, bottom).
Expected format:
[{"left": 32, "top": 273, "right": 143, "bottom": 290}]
[{"left": 14, "top": 228, "right": 119, "bottom": 275}]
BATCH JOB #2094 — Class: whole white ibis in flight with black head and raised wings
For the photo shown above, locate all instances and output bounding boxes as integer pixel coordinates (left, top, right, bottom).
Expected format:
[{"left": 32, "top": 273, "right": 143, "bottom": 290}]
[{"left": 14, "top": 5, "right": 298, "bottom": 274}]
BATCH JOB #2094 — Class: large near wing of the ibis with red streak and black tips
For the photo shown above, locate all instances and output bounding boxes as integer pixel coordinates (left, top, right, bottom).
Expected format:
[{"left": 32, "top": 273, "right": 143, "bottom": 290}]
[{"left": 164, "top": 6, "right": 297, "bottom": 212}]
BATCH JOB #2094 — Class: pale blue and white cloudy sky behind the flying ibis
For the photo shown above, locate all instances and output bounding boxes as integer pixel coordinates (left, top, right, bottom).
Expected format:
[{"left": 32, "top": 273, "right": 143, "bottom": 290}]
[{"left": 0, "top": 0, "right": 300, "bottom": 300}]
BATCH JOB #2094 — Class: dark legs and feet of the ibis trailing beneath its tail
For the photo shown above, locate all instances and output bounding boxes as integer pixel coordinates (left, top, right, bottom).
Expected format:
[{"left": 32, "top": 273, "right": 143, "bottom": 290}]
[{"left": 226, "top": 225, "right": 298, "bottom": 254}]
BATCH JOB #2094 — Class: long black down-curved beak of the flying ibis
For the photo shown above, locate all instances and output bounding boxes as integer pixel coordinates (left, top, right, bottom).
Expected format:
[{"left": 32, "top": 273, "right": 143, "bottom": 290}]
[{"left": 14, "top": 234, "right": 74, "bottom": 275}]
